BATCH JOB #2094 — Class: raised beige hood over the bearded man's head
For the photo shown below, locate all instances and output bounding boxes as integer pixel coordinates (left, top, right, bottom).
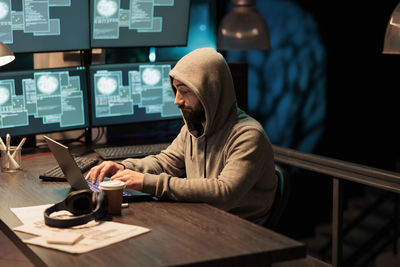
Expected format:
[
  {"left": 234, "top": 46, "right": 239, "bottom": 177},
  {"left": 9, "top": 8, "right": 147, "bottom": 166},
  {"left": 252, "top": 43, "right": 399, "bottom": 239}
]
[{"left": 169, "top": 48, "right": 236, "bottom": 135}]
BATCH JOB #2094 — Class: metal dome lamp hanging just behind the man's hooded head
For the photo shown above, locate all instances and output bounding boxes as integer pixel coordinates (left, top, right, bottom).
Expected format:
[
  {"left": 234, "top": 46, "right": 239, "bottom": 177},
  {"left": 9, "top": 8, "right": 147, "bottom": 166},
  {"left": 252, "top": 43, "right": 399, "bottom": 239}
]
[{"left": 217, "top": 0, "right": 271, "bottom": 50}]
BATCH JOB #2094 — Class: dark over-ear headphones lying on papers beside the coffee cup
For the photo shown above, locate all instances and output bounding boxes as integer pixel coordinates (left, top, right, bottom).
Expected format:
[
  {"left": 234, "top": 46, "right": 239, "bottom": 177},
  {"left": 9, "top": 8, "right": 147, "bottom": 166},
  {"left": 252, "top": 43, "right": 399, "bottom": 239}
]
[{"left": 44, "top": 189, "right": 107, "bottom": 228}]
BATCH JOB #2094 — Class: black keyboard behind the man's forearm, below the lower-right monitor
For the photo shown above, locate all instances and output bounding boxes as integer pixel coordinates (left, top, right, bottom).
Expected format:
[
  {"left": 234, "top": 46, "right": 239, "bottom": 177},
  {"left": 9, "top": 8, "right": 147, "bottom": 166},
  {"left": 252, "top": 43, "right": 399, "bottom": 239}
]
[{"left": 94, "top": 143, "right": 170, "bottom": 160}]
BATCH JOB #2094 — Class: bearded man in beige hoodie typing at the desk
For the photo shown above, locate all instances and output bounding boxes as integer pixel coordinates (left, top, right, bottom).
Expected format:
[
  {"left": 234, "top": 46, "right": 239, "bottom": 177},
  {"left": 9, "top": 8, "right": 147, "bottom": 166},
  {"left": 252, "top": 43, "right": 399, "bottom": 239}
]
[{"left": 86, "top": 48, "right": 277, "bottom": 224}]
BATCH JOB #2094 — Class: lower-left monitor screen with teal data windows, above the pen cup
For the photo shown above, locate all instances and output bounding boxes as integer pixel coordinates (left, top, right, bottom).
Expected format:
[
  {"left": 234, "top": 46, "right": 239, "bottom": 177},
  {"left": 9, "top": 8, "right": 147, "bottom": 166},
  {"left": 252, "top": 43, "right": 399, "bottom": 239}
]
[{"left": 0, "top": 67, "right": 89, "bottom": 136}]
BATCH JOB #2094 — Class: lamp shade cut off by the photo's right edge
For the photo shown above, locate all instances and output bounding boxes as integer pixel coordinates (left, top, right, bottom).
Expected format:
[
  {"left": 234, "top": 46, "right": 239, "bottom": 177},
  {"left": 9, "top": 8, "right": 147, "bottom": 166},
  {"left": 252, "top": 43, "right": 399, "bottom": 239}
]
[{"left": 383, "top": 3, "right": 400, "bottom": 54}]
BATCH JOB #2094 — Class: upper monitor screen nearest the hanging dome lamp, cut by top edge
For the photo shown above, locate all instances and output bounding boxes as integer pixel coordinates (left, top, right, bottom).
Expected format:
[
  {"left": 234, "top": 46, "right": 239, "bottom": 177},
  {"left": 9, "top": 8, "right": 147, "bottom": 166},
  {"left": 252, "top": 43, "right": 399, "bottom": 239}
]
[{"left": 90, "top": 0, "right": 190, "bottom": 47}]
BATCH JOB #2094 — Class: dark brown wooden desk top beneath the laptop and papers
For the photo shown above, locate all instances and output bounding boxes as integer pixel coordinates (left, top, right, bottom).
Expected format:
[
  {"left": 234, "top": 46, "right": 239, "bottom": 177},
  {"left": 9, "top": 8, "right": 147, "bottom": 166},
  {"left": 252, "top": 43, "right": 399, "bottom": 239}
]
[{"left": 0, "top": 153, "right": 306, "bottom": 266}]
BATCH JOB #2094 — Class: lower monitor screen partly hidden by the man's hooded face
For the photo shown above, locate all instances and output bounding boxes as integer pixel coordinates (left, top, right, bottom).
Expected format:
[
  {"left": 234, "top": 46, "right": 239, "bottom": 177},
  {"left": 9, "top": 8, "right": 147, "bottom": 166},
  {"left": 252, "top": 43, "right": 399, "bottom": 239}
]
[{"left": 90, "top": 62, "right": 181, "bottom": 126}]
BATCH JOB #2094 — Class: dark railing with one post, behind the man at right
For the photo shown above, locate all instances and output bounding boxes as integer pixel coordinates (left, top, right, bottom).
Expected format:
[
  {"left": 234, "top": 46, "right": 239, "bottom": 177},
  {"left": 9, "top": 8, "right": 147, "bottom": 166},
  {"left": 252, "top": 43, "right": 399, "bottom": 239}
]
[{"left": 272, "top": 145, "right": 400, "bottom": 267}]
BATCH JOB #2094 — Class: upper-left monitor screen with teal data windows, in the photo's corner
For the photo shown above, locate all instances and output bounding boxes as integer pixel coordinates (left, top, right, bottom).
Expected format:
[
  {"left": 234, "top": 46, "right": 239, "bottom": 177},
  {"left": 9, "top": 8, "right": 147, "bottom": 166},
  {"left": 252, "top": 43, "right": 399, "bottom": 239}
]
[{"left": 0, "top": 0, "right": 90, "bottom": 53}]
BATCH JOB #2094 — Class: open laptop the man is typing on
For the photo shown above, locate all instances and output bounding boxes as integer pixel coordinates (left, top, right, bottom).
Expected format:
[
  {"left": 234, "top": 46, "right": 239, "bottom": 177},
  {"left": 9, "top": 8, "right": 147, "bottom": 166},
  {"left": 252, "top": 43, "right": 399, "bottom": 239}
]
[{"left": 43, "top": 136, "right": 155, "bottom": 202}]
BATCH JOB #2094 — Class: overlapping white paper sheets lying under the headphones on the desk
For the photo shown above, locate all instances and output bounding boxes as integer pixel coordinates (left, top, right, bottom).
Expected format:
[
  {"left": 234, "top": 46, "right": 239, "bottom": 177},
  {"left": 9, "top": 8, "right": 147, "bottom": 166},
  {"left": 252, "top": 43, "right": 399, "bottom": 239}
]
[{"left": 11, "top": 205, "right": 150, "bottom": 253}]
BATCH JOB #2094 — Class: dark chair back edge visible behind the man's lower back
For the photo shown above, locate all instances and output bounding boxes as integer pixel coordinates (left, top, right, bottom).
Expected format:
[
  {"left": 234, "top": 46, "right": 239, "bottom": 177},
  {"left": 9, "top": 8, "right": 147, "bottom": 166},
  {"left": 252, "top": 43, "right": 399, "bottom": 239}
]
[{"left": 264, "top": 165, "right": 290, "bottom": 229}]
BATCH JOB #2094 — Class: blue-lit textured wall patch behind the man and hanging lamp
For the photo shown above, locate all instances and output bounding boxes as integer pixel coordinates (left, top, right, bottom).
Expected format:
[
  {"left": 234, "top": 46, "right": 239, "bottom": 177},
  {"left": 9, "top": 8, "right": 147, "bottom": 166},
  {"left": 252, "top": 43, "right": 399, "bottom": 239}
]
[{"left": 226, "top": 0, "right": 326, "bottom": 155}]
